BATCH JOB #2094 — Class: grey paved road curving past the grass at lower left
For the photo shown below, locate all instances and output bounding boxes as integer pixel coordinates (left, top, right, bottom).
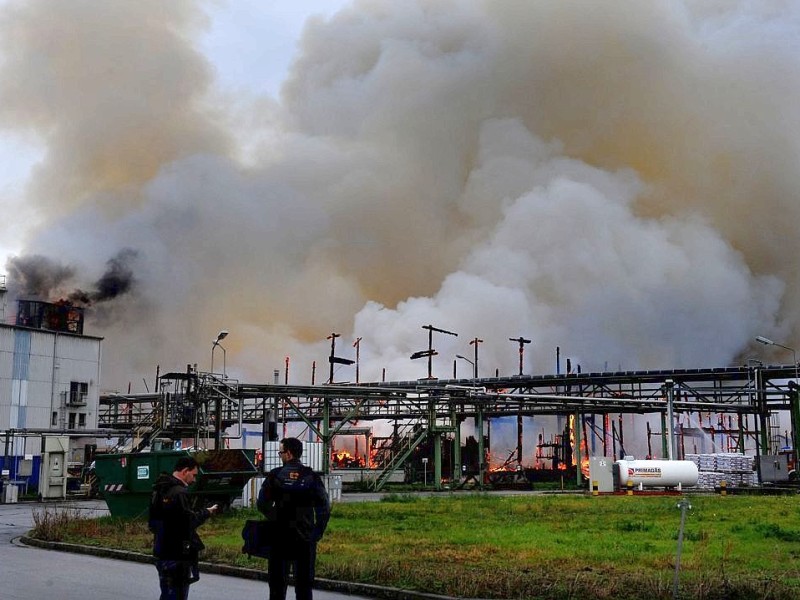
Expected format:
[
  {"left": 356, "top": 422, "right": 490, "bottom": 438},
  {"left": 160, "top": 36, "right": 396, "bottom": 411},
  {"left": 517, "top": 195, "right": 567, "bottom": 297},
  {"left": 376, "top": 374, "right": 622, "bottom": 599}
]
[{"left": 0, "top": 501, "right": 376, "bottom": 600}]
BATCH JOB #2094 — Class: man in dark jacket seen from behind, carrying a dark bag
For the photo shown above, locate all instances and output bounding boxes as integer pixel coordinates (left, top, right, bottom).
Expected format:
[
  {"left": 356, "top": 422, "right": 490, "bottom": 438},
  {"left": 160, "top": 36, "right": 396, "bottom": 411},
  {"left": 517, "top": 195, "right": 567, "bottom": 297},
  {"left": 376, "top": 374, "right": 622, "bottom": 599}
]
[{"left": 257, "top": 438, "right": 330, "bottom": 600}]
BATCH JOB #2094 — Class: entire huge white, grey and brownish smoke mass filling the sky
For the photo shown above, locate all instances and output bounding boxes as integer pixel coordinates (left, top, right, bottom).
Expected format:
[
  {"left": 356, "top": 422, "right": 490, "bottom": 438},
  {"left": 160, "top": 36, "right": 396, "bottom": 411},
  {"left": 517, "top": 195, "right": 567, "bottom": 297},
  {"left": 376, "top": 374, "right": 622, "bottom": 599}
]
[{"left": 0, "top": 0, "right": 800, "bottom": 388}]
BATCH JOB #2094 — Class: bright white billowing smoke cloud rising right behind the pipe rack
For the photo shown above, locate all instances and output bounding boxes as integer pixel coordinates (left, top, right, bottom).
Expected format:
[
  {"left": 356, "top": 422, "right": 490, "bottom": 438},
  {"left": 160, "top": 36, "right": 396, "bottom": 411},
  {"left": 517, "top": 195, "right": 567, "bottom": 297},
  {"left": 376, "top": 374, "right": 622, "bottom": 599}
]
[{"left": 356, "top": 116, "right": 783, "bottom": 376}]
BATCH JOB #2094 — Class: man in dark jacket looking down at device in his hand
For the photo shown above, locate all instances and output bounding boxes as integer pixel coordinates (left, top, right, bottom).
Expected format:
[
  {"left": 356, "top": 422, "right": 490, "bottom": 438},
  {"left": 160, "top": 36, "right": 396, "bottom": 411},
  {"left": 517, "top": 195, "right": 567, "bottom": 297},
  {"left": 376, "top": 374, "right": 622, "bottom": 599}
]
[{"left": 149, "top": 456, "right": 217, "bottom": 600}]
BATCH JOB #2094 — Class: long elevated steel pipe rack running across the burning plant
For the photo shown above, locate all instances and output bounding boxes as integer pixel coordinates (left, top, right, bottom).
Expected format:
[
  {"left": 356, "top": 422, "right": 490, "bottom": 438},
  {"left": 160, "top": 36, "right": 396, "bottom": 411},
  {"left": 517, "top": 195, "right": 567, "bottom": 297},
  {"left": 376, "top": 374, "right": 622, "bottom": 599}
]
[{"left": 99, "top": 365, "right": 800, "bottom": 489}]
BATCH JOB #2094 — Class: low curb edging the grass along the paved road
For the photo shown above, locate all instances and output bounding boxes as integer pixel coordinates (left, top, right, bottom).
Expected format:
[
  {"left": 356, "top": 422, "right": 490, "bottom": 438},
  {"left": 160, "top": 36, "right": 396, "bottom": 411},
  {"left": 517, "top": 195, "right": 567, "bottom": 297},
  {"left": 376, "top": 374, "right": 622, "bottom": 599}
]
[{"left": 16, "top": 535, "right": 458, "bottom": 600}]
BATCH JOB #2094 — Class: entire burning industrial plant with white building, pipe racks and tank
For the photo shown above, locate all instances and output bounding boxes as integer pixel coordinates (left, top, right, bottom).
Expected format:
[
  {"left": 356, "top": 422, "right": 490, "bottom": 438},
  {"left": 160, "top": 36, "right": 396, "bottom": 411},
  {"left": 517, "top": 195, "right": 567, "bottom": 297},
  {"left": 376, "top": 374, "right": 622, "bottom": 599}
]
[{"left": 0, "top": 280, "right": 800, "bottom": 511}]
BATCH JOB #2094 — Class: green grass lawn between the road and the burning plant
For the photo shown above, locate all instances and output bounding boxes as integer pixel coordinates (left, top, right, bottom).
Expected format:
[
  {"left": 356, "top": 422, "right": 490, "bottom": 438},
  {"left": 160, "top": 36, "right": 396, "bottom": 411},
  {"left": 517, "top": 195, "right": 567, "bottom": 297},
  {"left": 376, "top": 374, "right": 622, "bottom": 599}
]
[{"left": 28, "top": 494, "right": 800, "bottom": 600}]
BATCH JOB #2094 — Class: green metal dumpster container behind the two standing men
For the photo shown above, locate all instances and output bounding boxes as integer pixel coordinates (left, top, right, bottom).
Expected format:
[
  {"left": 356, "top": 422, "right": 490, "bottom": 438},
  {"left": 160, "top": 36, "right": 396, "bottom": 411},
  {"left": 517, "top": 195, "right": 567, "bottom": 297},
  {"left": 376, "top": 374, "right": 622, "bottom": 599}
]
[{"left": 95, "top": 450, "right": 258, "bottom": 517}]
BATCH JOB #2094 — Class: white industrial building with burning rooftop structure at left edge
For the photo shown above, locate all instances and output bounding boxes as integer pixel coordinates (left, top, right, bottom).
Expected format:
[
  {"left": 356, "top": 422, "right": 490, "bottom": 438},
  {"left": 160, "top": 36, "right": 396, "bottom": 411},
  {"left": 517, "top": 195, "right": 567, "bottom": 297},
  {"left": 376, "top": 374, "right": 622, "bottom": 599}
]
[{"left": 0, "top": 279, "right": 102, "bottom": 494}]
